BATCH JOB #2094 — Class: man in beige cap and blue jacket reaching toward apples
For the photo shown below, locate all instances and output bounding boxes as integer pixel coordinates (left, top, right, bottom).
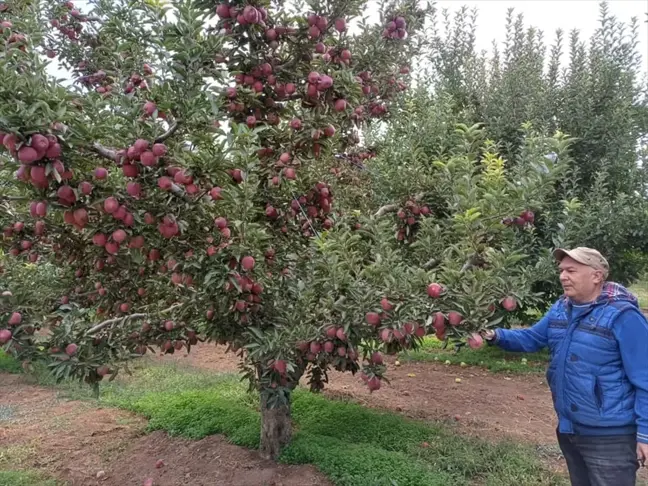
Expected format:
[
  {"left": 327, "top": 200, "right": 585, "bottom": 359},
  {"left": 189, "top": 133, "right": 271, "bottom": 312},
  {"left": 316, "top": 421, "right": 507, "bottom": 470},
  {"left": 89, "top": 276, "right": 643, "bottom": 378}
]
[{"left": 483, "top": 247, "right": 648, "bottom": 486}]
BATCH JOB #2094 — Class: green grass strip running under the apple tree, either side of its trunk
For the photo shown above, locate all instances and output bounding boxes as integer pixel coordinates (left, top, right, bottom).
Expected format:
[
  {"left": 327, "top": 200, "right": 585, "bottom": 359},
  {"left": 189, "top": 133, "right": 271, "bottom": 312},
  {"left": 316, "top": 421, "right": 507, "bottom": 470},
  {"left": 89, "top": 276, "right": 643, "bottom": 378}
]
[{"left": 50, "top": 363, "right": 566, "bottom": 486}]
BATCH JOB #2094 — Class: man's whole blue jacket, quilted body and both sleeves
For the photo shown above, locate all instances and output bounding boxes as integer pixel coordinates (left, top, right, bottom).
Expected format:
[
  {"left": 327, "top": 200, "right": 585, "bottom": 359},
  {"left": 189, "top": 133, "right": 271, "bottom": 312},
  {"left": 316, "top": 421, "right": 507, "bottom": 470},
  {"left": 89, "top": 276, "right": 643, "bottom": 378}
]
[{"left": 492, "top": 282, "right": 648, "bottom": 444}]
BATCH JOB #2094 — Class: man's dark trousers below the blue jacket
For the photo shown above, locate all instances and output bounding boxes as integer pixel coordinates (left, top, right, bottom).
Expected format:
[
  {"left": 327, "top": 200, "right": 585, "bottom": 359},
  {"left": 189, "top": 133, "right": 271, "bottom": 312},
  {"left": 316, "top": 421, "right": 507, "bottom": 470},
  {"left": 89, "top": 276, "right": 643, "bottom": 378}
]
[{"left": 558, "top": 433, "right": 639, "bottom": 486}]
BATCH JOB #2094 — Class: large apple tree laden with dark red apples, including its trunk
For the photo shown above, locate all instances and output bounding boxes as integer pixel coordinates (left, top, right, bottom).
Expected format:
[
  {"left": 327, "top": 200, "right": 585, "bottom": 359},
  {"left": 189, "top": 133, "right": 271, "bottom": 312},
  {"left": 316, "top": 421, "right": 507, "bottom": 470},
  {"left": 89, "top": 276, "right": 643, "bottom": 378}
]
[{"left": 0, "top": 0, "right": 440, "bottom": 458}]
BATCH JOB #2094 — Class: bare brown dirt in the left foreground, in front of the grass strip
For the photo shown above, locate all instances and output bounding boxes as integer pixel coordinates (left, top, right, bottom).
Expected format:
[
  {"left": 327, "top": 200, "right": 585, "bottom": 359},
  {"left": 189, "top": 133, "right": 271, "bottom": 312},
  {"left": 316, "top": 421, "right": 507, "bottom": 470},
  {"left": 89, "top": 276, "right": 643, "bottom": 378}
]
[{"left": 0, "top": 373, "right": 331, "bottom": 486}]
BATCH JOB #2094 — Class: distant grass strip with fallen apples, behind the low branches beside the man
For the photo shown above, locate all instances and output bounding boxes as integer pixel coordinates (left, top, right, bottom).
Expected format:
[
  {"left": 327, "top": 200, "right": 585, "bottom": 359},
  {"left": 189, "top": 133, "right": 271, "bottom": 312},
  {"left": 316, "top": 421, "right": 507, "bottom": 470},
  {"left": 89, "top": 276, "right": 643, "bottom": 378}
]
[{"left": 399, "top": 336, "right": 549, "bottom": 374}]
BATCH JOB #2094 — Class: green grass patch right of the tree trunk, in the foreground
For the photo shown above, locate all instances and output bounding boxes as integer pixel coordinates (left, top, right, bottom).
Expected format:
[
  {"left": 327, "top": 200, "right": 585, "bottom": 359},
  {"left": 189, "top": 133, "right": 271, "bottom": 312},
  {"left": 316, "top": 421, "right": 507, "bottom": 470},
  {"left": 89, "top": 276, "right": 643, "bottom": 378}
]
[{"left": 281, "top": 390, "right": 565, "bottom": 486}]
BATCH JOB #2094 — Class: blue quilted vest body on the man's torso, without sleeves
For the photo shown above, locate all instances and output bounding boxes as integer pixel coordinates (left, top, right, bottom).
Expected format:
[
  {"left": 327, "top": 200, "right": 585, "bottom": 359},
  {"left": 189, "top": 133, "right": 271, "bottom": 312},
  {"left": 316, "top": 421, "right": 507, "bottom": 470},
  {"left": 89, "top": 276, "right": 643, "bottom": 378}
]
[{"left": 547, "top": 298, "right": 636, "bottom": 434}]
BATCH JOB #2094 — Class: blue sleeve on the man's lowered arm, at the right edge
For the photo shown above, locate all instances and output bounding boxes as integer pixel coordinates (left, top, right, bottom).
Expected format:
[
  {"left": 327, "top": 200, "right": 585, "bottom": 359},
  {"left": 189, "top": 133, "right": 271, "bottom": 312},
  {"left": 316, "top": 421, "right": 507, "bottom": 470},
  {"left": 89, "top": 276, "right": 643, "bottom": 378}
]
[{"left": 613, "top": 310, "right": 648, "bottom": 444}]
